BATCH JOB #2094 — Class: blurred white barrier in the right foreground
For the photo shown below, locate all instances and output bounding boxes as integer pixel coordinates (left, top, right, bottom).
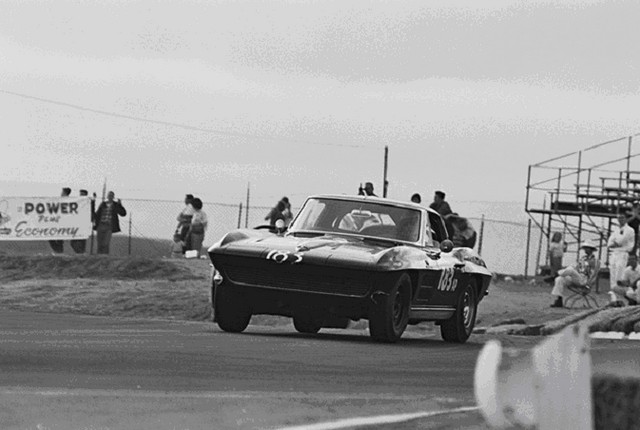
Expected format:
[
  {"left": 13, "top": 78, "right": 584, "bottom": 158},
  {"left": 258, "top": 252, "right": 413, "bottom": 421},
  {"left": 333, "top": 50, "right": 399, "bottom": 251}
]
[{"left": 474, "top": 325, "right": 593, "bottom": 430}]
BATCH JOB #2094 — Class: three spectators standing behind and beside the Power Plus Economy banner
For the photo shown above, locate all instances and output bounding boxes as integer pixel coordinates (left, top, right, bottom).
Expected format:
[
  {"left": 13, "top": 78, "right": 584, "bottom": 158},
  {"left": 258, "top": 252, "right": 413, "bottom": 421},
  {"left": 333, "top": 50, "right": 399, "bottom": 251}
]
[{"left": 49, "top": 187, "right": 127, "bottom": 254}]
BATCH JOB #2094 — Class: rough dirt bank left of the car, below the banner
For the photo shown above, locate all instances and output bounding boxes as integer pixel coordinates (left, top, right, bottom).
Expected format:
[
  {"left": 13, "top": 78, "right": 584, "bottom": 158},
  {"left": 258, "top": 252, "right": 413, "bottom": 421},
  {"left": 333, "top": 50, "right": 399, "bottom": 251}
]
[{"left": 0, "top": 255, "right": 211, "bottom": 320}]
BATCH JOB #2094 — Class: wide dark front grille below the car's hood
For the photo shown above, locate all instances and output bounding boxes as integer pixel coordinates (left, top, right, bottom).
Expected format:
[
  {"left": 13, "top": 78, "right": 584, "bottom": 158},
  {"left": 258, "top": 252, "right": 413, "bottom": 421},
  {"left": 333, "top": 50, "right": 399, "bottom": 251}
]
[{"left": 221, "top": 257, "right": 371, "bottom": 297}]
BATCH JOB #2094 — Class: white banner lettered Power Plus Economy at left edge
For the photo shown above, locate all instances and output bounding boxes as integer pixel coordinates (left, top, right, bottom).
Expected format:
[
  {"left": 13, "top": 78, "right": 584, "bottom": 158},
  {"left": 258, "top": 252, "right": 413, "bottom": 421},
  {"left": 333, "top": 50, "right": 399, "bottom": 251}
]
[{"left": 0, "top": 197, "right": 91, "bottom": 240}]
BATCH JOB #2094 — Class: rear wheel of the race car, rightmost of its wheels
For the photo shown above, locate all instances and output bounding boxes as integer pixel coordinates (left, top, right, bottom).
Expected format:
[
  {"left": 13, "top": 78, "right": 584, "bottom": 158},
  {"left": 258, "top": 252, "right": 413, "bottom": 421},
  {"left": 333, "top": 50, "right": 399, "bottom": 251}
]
[{"left": 440, "top": 279, "right": 478, "bottom": 343}]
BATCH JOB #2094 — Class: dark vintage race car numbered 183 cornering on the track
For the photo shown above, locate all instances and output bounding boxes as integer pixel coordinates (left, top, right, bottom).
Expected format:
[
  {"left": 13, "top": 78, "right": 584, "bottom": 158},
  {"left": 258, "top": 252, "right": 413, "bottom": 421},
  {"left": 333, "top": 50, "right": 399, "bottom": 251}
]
[{"left": 208, "top": 195, "right": 492, "bottom": 343}]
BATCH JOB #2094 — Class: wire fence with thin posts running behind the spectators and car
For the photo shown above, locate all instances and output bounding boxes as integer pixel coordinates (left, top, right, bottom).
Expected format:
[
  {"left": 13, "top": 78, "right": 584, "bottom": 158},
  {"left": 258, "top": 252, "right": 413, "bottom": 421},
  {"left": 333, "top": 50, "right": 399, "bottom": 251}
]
[{"left": 0, "top": 199, "right": 552, "bottom": 275}]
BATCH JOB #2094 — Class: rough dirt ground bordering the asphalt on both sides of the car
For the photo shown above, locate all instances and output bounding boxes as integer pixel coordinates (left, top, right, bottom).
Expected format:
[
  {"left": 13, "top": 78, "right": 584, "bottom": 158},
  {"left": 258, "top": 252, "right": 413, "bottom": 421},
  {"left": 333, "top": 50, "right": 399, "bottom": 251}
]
[{"left": 0, "top": 255, "right": 607, "bottom": 330}]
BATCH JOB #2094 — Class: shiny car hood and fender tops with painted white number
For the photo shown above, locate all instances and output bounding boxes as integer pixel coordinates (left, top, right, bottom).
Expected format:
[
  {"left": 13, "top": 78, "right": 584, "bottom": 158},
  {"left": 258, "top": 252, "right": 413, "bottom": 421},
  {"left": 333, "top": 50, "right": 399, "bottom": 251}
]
[{"left": 209, "top": 230, "right": 425, "bottom": 269}]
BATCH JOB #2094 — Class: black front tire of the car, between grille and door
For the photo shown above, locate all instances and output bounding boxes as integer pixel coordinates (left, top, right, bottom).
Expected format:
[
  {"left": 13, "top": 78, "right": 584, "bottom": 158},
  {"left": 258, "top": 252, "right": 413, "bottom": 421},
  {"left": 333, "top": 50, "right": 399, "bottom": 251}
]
[{"left": 369, "top": 273, "right": 411, "bottom": 343}]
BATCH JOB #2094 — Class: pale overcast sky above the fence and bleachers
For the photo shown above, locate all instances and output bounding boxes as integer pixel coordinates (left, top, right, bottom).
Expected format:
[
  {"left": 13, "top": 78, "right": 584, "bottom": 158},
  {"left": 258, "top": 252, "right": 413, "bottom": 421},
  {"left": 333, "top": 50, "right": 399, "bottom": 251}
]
[{"left": 0, "top": 0, "right": 640, "bottom": 205}]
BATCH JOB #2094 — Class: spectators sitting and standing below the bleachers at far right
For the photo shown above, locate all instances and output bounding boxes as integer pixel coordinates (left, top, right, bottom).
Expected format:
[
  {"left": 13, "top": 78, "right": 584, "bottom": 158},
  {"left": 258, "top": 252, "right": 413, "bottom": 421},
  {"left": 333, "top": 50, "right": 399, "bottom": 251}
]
[{"left": 549, "top": 207, "right": 640, "bottom": 307}]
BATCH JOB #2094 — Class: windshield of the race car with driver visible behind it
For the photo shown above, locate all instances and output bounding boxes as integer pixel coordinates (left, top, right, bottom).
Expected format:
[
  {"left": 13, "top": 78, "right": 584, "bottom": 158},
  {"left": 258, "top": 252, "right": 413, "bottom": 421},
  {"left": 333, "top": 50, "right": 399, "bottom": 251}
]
[{"left": 289, "top": 198, "right": 421, "bottom": 242}]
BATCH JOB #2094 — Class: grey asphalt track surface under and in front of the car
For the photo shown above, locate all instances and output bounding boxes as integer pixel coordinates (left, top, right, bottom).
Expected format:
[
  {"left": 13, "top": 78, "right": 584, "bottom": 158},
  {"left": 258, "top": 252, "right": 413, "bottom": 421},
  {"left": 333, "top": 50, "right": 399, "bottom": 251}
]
[{"left": 0, "top": 310, "right": 640, "bottom": 430}]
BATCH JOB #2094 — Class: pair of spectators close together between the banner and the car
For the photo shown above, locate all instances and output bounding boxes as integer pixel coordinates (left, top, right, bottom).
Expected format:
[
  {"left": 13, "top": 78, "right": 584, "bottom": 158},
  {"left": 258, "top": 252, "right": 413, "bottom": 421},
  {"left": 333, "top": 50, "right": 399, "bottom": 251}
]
[{"left": 171, "top": 194, "right": 209, "bottom": 258}]
